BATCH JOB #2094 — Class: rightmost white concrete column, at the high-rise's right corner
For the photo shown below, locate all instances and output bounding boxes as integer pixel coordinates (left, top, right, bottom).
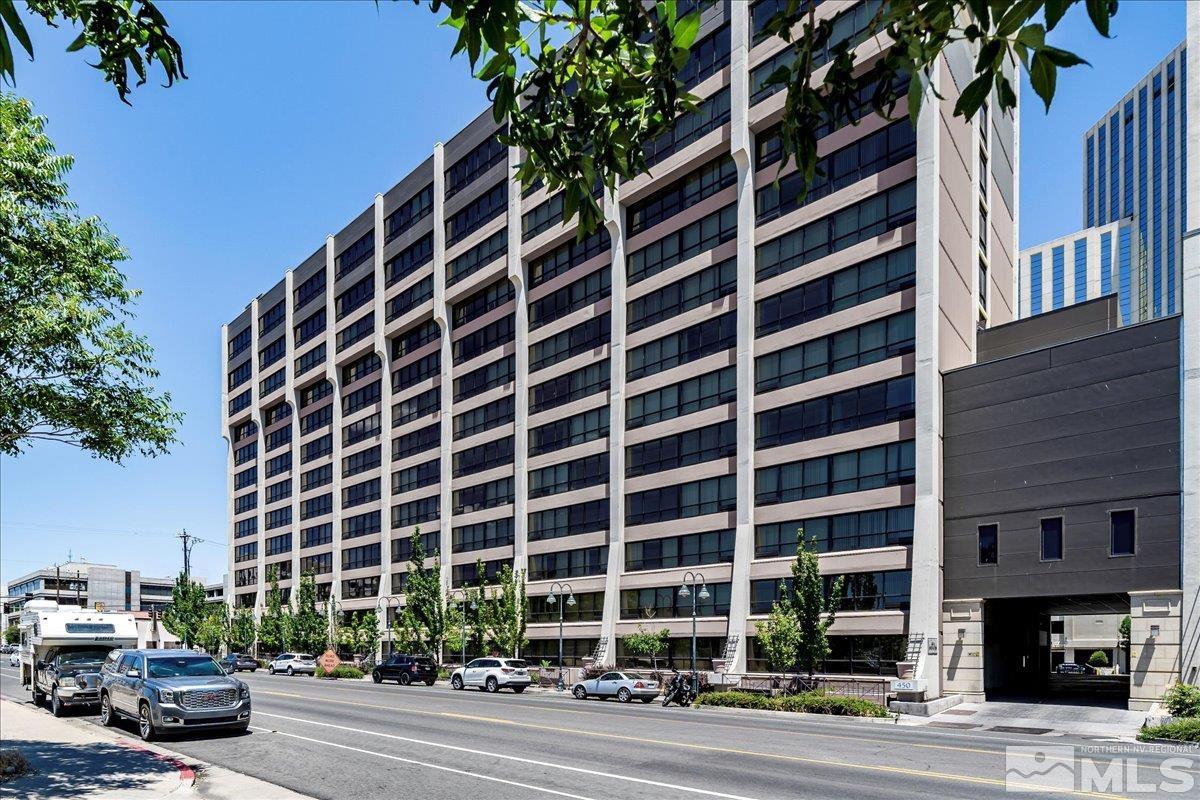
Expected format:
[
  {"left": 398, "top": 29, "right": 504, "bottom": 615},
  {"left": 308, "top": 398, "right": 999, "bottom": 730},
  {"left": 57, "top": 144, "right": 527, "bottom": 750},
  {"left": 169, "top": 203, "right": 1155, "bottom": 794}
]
[{"left": 908, "top": 64, "right": 942, "bottom": 698}]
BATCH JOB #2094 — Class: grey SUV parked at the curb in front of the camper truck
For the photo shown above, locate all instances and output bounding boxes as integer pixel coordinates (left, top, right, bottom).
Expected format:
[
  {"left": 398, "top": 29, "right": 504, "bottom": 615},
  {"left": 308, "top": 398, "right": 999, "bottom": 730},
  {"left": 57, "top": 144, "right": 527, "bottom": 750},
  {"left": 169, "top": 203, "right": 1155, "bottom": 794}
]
[{"left": 100, "top": 650, "right": 250, "bottom": 741}]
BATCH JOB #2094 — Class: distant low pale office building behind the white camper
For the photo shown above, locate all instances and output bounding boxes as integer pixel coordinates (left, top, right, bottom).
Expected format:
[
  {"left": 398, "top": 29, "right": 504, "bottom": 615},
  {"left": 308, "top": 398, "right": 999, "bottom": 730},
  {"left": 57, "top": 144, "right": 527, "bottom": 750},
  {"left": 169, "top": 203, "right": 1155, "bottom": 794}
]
[{"left": 4, "top": 561, "right": 175, "bottom": 624}]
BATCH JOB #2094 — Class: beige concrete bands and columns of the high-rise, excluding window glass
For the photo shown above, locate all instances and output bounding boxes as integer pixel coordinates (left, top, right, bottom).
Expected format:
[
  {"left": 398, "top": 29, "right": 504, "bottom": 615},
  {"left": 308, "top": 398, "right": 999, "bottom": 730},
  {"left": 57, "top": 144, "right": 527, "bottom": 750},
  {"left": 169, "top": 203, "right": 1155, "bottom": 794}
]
[{"left": 222, "top": 0, "right": 1016, "bottom": 685}]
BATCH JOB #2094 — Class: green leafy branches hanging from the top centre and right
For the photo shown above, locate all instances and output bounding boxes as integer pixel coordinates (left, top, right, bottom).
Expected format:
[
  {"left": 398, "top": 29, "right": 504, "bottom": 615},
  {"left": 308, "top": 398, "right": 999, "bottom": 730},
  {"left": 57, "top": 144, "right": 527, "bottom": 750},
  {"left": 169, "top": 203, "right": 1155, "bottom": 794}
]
[{"left": 426, "top": 0, "right": 1117, "bottom": 233}]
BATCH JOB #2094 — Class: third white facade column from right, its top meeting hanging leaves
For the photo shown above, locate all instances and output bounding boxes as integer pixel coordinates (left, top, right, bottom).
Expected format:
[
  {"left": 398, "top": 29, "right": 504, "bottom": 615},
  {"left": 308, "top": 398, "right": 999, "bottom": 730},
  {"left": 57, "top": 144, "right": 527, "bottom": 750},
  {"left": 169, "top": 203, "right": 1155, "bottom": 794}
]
[{"left": 599, "top": 184, "right": 626, "bottom": 663}]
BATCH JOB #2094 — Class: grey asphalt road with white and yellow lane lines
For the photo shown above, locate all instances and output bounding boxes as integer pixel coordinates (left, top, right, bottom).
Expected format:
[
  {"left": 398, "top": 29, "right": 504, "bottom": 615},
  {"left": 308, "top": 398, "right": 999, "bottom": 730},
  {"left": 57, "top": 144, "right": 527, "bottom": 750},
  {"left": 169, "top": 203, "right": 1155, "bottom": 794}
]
[{"left": 0, "top": 668, "right": 1200, "bottom": 800}]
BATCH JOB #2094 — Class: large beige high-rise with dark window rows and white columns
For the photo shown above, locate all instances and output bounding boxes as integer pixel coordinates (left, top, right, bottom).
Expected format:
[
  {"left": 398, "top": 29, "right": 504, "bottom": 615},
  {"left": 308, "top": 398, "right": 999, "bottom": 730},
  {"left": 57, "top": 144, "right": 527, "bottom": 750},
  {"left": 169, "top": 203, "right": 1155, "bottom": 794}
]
[{"left": 221, "top": 0, "right": 1018, "bottom": 693}]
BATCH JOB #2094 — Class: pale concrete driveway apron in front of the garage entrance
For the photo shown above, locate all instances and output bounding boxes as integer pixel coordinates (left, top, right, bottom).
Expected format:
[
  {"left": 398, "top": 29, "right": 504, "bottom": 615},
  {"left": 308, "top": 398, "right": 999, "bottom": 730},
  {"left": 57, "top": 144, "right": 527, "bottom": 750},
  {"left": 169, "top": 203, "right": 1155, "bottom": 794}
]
[{"left": 926, "top": 702, "right": 1146, "bottom": 740}]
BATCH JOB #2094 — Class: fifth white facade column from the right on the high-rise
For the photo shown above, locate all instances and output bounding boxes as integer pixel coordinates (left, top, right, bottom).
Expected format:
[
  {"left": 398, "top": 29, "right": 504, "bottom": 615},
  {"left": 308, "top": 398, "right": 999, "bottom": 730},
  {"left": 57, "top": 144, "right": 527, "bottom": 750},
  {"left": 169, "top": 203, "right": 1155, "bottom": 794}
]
[{"left": 433, "top": 142, "right": 454, "bottom": 606}]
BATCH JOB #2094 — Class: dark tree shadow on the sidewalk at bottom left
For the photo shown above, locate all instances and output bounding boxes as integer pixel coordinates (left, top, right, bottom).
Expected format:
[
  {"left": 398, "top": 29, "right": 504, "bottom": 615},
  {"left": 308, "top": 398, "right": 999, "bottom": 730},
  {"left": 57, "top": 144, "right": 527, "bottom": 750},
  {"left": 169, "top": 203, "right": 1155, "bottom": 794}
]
[{"left": 4, "top": 739, "right": 178, "bottom": 798}]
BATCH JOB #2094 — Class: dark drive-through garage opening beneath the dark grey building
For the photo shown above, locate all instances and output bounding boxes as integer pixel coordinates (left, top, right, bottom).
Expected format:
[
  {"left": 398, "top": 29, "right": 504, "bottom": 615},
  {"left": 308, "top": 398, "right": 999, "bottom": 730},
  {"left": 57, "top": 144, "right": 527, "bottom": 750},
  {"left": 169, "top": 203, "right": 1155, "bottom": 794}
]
[{"left": 983, "top": 594, "right": 1129, "bottom": 708}]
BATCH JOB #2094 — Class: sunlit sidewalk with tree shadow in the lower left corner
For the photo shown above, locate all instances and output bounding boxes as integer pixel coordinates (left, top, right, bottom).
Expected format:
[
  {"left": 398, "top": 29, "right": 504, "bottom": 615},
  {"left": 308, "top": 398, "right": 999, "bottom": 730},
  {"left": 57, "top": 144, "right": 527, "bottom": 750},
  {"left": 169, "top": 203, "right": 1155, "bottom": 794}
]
[{"left": 0, "top": 698, "right": 306, "bottom": 800}]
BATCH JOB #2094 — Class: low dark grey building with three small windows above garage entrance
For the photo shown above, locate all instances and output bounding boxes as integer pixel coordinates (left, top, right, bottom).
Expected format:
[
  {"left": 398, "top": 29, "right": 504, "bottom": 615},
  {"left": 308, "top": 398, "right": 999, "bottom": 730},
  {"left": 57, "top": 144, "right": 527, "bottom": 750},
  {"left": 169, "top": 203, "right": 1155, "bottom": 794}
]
[{"left": 942, "top": 295, "right": 1200, "bottom": 709}]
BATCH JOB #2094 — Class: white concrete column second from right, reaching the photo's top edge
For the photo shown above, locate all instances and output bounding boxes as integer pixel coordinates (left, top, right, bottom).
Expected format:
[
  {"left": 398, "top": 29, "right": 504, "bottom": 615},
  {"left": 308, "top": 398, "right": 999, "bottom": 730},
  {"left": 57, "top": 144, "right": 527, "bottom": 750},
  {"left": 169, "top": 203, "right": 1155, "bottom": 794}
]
[{"left": 725, "top": 4, "right": 755, "bottom": 674}]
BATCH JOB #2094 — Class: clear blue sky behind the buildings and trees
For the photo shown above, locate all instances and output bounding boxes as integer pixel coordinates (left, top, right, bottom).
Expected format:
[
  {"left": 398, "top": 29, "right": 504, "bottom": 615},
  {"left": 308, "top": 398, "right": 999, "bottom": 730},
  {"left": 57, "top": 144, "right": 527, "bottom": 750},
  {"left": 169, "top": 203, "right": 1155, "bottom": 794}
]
[{"left": 0, "top": 0, "right": 1184, "bottom": 581}]
